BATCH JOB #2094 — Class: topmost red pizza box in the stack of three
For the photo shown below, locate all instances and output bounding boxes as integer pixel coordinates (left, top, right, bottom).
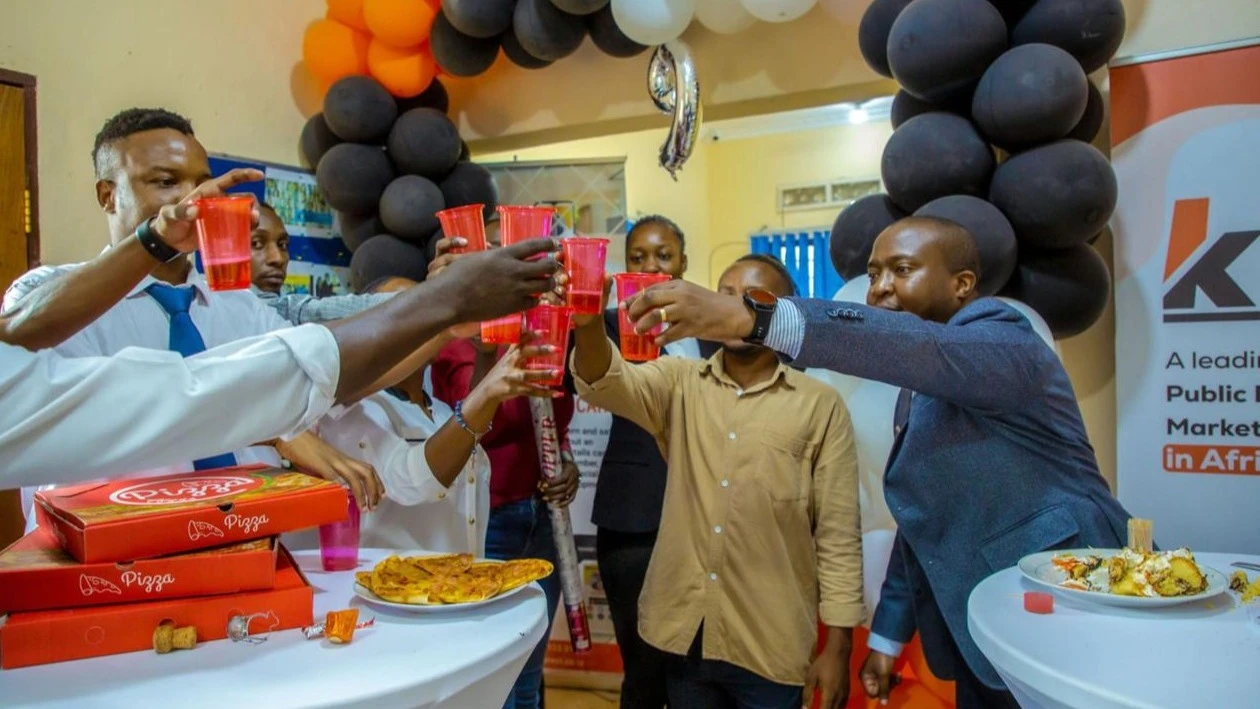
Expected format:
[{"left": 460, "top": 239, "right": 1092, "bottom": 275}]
[{"left": 35, "top": 466, "right": 349, "bottom": 564}]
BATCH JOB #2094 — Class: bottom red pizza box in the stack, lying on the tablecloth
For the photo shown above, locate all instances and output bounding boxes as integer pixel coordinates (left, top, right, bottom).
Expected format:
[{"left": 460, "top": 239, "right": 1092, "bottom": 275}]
[{"left": 0, "top": 548, "right": 315, "bottom": 670}]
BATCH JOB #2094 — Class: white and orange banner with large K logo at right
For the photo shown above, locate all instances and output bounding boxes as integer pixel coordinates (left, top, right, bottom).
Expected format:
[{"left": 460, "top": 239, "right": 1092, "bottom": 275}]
[{"left": 1111, "top": 39, "right": 1260, "bottom": 554}]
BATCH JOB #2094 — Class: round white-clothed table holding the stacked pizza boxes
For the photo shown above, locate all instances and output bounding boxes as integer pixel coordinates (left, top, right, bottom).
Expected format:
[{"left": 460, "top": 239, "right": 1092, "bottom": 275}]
[{"left": 0, "top": 549, "right": 548, "bottom": 709}]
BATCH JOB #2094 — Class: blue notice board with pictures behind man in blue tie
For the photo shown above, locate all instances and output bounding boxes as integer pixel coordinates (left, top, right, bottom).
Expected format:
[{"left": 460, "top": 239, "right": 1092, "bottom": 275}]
[{"left": 207, "top": 155, "right": 350, "bottom": 296}]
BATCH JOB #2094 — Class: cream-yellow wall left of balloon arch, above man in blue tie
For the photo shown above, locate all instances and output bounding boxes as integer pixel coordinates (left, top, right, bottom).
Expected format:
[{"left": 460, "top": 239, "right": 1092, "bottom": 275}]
[{"left": 0, "top": 0, "right": 324, "bottom": 263}]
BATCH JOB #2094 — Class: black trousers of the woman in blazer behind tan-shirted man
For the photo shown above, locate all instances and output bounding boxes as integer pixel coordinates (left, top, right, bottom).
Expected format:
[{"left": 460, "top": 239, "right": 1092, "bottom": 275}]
[{"left": 595, "top": 526, "right": 687, "bottom": 709}]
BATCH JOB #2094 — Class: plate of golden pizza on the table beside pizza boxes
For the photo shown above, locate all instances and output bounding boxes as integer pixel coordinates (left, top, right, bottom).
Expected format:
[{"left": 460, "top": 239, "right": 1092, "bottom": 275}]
[{"left": 354, "top": 553, "right": 553, "bottom": 613}]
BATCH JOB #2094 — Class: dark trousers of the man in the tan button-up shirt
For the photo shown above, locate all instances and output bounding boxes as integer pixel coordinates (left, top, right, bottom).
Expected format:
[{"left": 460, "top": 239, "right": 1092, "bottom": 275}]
[{"left": 668, "top": 627, "right": 805, "bottom": 709}]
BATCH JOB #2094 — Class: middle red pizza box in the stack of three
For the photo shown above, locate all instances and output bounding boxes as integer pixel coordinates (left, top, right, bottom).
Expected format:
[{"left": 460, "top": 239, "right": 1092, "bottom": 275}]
[{"left": 0, "top": 529, "right": 277, "bottom": 613}]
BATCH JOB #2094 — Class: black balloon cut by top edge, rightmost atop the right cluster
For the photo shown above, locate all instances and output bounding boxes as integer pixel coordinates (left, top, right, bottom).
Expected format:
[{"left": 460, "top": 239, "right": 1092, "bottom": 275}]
[{"left": 1011, "top": 0, "right": 1124, "bottom": 73}]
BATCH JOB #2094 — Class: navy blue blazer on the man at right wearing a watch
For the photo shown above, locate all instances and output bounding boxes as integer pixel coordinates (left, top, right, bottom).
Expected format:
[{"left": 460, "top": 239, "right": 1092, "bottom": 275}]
[{"left": 793, "top": 298, "right": 1129, "bottom": 688}]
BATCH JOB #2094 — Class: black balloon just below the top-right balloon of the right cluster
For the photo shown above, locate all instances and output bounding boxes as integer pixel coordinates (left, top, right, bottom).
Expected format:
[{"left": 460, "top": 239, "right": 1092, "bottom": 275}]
[{"left": 971, "top": 44, "right": 1090, "bottom": 151}]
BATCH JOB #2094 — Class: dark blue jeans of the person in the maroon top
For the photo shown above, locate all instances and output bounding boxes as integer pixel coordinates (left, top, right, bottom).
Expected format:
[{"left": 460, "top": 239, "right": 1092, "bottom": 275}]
[{"left": 485, "top": 497, "right": 559, "bottom": 709}]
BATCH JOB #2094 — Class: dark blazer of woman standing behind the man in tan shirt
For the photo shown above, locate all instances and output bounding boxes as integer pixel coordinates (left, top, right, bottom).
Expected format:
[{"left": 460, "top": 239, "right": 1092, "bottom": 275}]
[{"left": 591, "top": 309, "right": 718, "bottom": 533}]
